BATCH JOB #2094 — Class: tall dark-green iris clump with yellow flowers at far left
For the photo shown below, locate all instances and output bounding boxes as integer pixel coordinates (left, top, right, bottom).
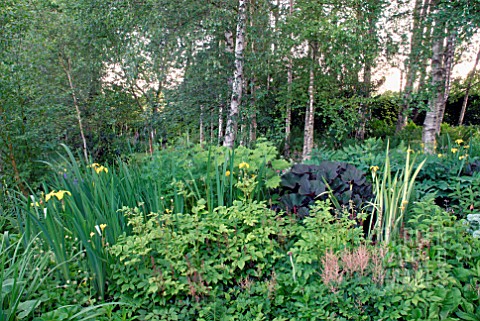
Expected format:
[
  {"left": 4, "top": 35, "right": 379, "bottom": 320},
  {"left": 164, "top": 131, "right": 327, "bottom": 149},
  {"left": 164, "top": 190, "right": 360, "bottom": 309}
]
[{"left": 18, "top": 147, "right": 172, "bottom": 296}]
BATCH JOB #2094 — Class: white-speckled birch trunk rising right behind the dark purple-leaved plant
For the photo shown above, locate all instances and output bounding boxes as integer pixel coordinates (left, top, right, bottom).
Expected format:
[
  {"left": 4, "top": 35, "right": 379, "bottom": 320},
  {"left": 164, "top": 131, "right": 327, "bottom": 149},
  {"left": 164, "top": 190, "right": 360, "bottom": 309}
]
[{"left": 302, "top": 43, "right": 317, "bottom": 160}]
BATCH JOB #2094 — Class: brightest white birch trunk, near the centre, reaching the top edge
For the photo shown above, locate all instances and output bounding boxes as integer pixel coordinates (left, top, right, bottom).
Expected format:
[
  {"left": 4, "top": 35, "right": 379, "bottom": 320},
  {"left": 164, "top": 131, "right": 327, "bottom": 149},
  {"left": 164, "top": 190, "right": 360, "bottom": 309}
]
[{"left": 223, "top": 0, "right": 247, "bottom": 148}]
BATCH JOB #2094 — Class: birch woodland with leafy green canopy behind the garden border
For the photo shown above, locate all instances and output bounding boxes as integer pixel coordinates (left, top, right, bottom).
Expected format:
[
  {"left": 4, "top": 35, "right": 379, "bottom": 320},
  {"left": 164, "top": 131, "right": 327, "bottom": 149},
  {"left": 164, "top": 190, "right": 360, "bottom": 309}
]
[{"left": 0, "top": 0, "right": 480, "bottom": 185}]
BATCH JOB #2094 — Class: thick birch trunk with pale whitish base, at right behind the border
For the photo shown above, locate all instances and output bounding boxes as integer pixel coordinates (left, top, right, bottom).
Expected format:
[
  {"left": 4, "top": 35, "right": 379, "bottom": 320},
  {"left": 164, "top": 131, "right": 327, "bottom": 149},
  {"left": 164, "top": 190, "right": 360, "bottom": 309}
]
[{"left": 422, "top": 18, "right": 445, "bottom": 154}]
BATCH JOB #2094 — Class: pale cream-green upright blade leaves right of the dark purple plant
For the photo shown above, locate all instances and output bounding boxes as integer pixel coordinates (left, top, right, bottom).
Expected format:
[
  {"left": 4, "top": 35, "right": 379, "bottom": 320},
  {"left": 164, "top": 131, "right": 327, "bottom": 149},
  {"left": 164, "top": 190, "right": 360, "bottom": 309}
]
[{"left": 369, "top": 145, "right": 426, "bottom": 244}]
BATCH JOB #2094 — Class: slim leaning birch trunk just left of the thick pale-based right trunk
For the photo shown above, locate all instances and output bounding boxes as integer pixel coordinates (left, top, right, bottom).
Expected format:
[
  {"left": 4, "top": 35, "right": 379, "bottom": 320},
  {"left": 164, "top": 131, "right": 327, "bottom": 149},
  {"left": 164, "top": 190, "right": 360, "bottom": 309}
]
[{"left": 395, "top": 0, "right": 424, "bottom": 133}]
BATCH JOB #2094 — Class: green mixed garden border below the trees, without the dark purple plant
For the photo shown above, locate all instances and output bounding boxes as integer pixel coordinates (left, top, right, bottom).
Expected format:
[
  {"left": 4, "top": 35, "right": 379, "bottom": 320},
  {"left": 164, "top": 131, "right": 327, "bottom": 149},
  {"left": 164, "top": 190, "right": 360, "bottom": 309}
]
[{"left": 2, "top": 136, "right": 480, "bottom": 320}]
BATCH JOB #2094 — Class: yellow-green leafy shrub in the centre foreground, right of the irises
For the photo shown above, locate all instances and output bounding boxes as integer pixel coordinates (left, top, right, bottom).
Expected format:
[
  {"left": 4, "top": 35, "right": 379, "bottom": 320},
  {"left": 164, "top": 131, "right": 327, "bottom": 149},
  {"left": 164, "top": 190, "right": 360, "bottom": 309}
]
[{"left": 109, "top": 200, "right": 283, "bottom": 318}]
